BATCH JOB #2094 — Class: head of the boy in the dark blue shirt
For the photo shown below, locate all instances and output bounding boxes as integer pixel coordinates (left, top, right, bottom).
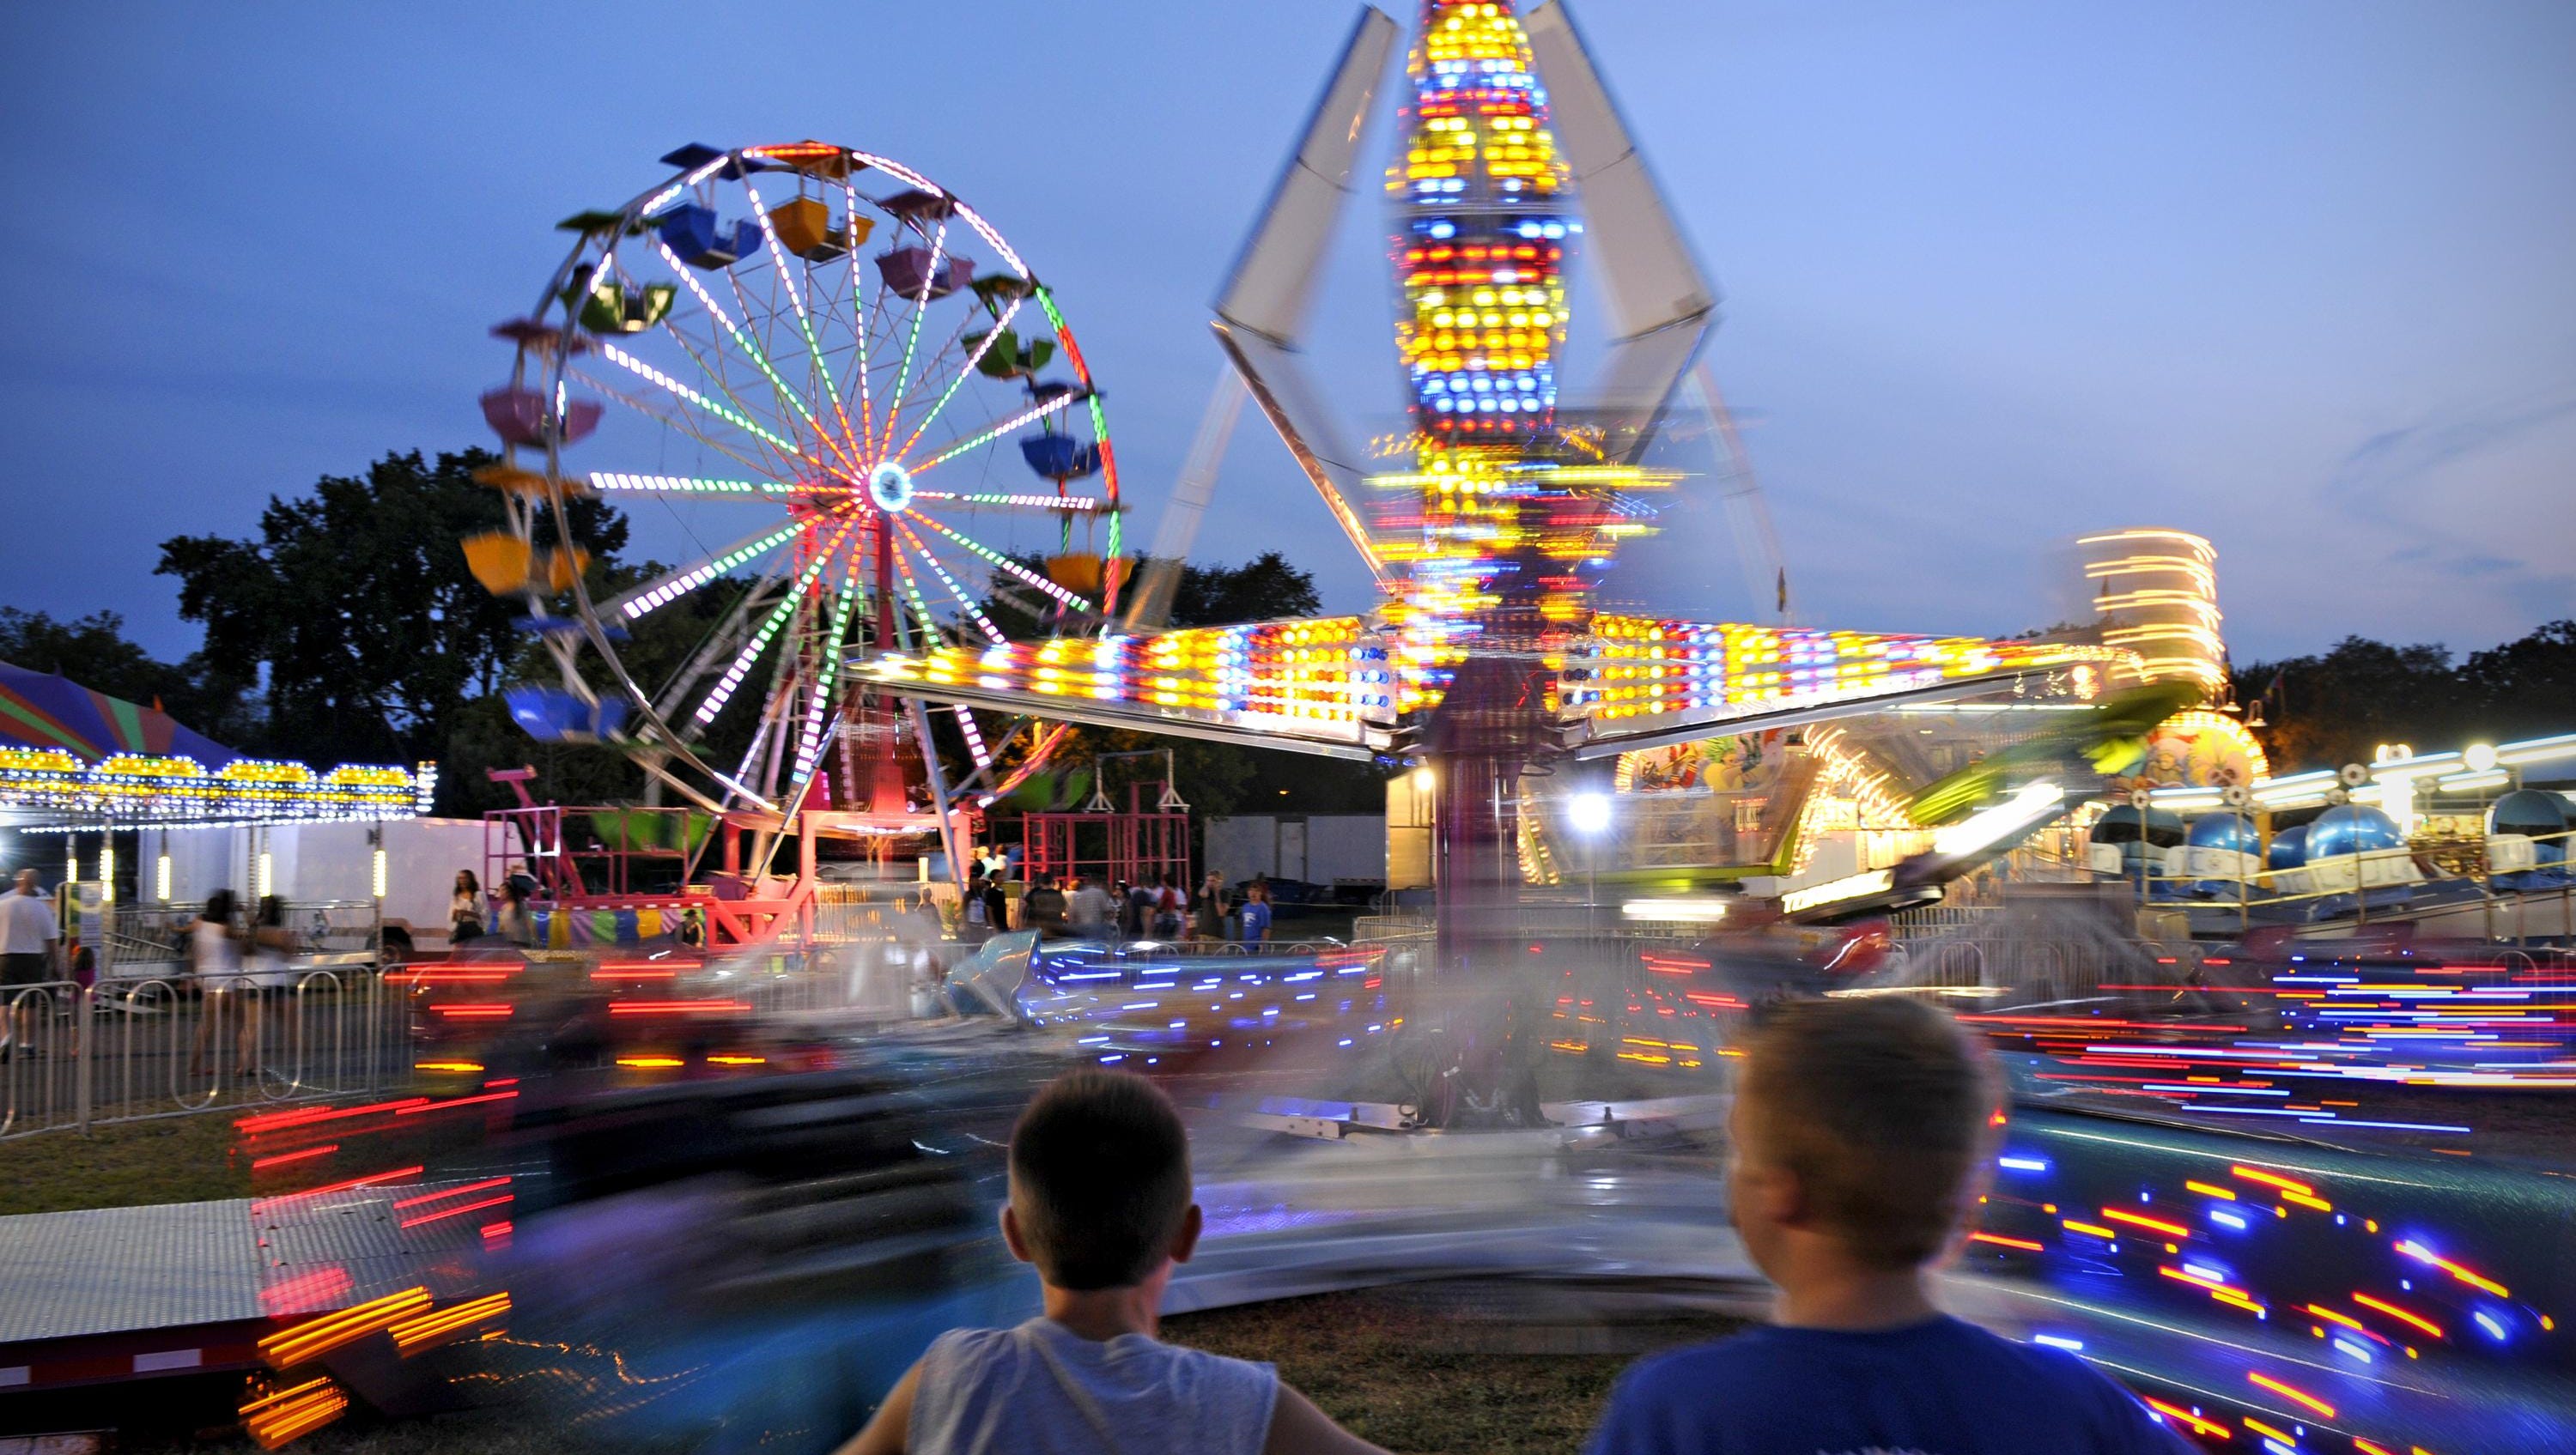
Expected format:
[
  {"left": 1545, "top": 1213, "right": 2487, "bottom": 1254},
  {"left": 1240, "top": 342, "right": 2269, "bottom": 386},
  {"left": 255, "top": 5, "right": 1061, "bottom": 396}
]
[{"left": 1728, "top": 997, "right": 1994, "bottom": 1282}]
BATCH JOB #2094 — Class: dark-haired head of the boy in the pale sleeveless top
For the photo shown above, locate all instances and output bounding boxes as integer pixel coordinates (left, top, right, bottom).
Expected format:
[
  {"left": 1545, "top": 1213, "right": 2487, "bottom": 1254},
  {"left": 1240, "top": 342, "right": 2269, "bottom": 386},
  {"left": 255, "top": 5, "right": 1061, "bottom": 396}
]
[{"left": 1010, "top": 1066, "right": 1190, "bottom": 1290}]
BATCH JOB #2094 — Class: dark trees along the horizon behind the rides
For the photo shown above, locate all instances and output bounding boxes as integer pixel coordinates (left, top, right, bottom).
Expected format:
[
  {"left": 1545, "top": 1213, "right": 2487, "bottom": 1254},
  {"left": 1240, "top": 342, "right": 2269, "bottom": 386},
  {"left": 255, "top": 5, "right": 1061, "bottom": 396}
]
[{"left": 15, "top": 448, "right": 2576, "bottom": 814}]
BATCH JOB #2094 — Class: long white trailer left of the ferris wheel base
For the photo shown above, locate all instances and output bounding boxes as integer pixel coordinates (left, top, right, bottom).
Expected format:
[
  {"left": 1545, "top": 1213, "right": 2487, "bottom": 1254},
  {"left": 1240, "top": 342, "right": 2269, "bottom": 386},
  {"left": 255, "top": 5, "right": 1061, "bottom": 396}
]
[{"left": 134, "top": 819, "right": 484, "bottom": 950}]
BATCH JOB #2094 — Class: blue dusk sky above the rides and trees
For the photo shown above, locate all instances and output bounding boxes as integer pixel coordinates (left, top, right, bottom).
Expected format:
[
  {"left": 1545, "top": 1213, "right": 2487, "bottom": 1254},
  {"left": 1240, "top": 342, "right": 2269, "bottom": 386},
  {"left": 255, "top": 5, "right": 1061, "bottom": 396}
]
[{"left": 0, "top": 0, "right": 2576, "bottom": 659}]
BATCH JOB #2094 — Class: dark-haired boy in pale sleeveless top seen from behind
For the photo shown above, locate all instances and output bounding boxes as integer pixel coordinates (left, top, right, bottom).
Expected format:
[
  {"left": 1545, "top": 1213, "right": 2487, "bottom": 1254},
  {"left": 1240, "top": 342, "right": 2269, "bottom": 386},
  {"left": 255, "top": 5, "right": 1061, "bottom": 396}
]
[{"left": 840, "top": 1069, "right": 1383, "bottom": 1455}]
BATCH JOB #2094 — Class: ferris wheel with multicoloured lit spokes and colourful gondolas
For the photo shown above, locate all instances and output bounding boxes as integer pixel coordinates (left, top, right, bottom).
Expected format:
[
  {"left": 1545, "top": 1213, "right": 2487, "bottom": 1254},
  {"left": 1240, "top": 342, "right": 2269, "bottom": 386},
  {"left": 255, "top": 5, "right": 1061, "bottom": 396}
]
[{"left": 466, "top": 142, "right": 1121, "bottom": 827}]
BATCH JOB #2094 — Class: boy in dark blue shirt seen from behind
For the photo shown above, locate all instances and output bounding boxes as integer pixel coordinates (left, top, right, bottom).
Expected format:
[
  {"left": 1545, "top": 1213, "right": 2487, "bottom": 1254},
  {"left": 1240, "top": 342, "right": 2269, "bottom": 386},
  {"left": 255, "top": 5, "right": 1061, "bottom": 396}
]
[{"left": 1592, "top": 997, "right": 2192, "bottom": 1455}]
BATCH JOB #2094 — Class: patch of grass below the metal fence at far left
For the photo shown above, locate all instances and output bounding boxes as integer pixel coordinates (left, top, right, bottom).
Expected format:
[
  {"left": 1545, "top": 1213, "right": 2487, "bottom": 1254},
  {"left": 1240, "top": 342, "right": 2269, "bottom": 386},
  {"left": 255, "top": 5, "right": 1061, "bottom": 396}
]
[{"left": 0, "top": 1112, "right": 250, "bottom": 1216}]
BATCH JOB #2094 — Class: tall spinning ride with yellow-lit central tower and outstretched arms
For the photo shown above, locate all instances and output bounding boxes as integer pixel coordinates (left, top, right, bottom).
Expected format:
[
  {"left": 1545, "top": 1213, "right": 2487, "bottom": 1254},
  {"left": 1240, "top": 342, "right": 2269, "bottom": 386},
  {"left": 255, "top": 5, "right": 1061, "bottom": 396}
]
[{"left": 860, "top": 0, "right": 2138, "bottom": 943}]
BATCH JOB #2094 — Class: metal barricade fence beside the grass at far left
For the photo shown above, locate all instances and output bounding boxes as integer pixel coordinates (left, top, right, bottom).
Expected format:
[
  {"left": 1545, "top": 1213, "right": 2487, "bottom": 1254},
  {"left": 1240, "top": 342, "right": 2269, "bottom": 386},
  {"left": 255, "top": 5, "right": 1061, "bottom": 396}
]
[{"left": 0, "top": 968, "right": 412, "bottom": 1138}]
